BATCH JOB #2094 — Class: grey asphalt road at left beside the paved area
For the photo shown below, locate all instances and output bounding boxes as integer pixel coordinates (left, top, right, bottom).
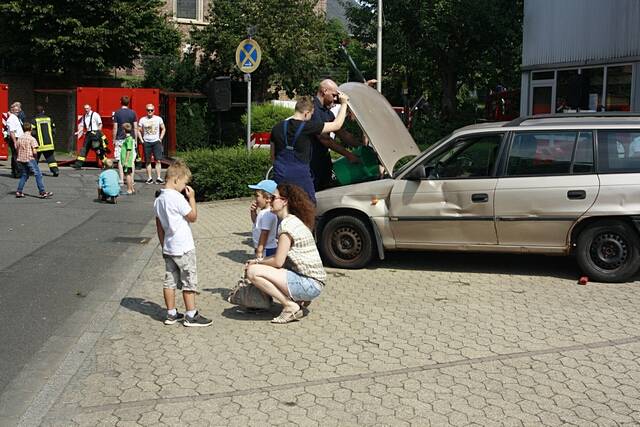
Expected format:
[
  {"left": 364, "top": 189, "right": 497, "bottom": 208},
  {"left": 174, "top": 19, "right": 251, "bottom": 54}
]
[{"left": 0, "top": 162, "right": 159, "bottom": 395}]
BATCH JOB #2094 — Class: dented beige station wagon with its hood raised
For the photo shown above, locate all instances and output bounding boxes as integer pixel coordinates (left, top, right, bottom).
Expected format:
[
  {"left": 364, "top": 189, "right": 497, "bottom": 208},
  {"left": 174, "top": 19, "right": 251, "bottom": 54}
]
[{"left": 316, "top": 83, "right": 640, "bottom": 282}]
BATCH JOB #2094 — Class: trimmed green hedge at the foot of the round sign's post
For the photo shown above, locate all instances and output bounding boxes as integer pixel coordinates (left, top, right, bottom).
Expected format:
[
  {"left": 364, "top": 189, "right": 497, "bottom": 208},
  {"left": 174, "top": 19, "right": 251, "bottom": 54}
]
[{"left": 180, "top": 146, "right": 271, "bottom": 201}]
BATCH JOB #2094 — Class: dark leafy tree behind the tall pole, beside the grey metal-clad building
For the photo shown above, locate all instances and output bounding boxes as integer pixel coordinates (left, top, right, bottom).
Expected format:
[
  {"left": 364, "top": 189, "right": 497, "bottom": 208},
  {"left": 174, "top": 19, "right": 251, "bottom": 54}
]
[{"left": 347, "top": 0, "right": 523, "bottom": 118}]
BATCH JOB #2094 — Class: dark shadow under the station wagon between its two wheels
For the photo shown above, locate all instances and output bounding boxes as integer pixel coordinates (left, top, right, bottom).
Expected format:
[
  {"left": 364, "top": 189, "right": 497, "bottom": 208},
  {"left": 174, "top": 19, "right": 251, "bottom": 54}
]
[{"left": 369, "top": 251, "right": 580, "bottom": 280}]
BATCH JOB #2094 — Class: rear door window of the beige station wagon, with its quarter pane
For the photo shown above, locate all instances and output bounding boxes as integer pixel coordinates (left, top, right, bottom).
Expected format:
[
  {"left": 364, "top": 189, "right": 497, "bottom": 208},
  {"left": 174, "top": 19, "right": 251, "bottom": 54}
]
[{"left": 507, "top": 131, "right": 593, "bottom": 176}]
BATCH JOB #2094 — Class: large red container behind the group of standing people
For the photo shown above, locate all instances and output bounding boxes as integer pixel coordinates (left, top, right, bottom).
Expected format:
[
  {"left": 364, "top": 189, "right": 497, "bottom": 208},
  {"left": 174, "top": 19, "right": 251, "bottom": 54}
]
[{"left": 75, "top": 87, "right": 160, "bottom": 166}]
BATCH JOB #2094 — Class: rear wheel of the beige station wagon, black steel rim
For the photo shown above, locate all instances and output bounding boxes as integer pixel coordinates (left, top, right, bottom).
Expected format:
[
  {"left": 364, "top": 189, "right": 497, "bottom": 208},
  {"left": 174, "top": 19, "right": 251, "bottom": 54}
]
[{"left": 576, "top": 221, "right": 640, "bottom": 282}]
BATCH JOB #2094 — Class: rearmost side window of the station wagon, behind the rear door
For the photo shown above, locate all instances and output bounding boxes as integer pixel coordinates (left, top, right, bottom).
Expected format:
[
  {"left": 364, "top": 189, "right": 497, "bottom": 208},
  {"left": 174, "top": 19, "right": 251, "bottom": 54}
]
[{"left": 598, "top": 130, "right": 640, "bottom": 173}]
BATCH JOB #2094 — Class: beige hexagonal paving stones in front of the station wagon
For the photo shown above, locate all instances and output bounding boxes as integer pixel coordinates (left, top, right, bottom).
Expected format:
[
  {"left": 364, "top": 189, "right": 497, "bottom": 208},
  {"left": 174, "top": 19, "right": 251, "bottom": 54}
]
[{"left": 36, "top": 200, "right": 640, "bottom": 426}]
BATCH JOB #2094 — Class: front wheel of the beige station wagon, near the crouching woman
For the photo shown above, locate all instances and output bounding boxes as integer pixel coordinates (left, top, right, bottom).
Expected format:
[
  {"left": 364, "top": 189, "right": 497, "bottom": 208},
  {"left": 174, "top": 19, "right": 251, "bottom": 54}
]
[{"left": 319, "top": 215, "right": 374, "bottom": 269}]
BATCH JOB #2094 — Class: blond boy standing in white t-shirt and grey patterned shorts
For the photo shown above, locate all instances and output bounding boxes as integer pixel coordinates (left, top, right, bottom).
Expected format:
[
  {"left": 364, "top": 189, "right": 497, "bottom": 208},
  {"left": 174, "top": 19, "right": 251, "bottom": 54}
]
[{"left": 153, "top": 160, "right": 213, "bottom": 326}]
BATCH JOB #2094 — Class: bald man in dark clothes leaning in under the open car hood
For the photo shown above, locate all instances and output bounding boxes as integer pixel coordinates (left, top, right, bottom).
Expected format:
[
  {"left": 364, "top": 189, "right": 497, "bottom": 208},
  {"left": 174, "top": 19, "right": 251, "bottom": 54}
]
[{"left": 311, "top": 79, "right": 362, "bottom": 191}]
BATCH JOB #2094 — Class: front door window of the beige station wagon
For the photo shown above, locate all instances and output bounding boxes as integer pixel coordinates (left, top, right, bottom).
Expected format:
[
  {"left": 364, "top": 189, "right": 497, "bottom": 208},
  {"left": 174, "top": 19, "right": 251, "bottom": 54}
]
[{"left": 424, "top": 134, "right": 502, "bottom": 179}]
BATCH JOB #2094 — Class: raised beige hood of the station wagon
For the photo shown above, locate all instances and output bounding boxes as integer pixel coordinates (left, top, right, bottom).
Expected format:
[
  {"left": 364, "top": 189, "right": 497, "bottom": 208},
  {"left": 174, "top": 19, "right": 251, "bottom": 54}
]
[{"left": 339, "top": 82, "right": 420, "bottom": 175}]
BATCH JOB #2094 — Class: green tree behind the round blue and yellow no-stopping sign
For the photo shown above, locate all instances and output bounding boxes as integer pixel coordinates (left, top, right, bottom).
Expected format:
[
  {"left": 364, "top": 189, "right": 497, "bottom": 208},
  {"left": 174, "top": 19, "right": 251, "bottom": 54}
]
[{"left": 192, "top": 0, "right": 344, "bottom": 101}]
